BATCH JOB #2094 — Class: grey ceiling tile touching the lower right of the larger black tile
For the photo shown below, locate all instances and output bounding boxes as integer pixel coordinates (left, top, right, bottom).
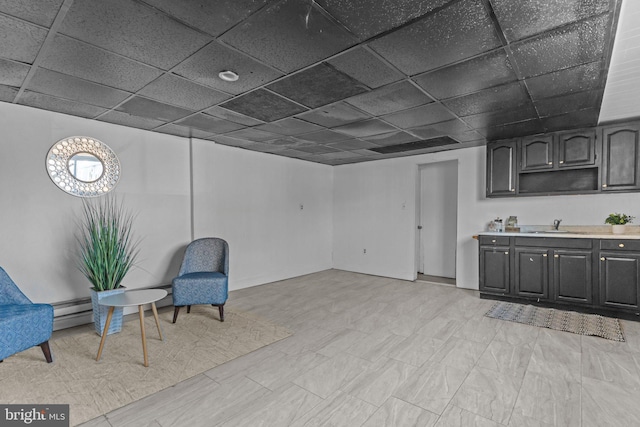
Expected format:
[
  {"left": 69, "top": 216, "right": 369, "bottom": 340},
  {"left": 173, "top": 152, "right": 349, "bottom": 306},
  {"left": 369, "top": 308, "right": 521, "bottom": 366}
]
[{"left": 346, "top": 80, "right": 433, "bottom": 116}]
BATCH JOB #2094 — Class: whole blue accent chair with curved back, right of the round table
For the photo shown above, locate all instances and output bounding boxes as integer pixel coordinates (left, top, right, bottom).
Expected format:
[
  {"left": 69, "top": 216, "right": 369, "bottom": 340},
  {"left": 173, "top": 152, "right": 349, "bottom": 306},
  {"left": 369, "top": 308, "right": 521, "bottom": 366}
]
[{"left": 171, "top": 237, "right": 229, "bottom": 323}]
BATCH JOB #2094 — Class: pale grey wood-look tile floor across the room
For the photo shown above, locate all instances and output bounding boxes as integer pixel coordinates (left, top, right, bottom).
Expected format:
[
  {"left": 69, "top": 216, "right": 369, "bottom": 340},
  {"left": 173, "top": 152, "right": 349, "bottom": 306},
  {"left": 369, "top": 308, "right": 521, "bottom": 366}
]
[{"left": 84, "top": 270, "right": 640, "bottom": 427}]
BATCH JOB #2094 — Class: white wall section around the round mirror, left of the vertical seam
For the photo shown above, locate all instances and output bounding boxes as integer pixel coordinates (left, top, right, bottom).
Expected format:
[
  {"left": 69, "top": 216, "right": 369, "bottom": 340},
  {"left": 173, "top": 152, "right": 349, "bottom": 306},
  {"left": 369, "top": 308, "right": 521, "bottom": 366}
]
[{"left": 0, "top": 103, "right": 189, "bottom": 302}]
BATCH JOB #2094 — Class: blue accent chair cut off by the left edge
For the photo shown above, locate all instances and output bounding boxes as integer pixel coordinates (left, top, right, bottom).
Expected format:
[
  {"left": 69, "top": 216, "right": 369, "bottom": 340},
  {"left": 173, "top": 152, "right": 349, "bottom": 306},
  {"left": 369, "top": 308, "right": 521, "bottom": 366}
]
[{"left": 0, "top": 267, "right": 53, "bottom": 363}]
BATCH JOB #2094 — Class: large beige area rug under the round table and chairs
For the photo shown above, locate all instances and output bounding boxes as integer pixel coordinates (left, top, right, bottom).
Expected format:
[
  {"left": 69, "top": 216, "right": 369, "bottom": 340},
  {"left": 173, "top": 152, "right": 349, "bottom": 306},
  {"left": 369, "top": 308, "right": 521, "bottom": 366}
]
[{"left": 0, "top": 306, "right": 291, "bottom": 426}]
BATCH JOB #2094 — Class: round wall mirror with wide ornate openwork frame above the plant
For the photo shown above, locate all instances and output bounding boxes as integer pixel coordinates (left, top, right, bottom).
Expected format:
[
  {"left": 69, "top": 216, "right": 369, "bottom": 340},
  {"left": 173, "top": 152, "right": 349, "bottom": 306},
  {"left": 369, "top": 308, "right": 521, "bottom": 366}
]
[{"left": 46, "top": 136, "right": 120, "bottom": 197}]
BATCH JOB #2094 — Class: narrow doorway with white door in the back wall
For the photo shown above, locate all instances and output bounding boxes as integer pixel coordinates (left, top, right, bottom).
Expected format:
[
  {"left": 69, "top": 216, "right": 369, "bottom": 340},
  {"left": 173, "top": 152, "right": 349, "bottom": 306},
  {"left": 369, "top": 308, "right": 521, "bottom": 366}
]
[{"left": 417, "top": 160, "right": 458, "bottom": 284}]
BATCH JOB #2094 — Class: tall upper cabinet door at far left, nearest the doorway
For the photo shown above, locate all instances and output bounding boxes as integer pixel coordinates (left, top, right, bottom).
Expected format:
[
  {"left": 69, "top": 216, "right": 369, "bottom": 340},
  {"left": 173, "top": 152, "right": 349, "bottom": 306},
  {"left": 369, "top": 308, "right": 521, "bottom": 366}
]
[{"left": 487, "top": 141, "right": 516, "bottom": 197}]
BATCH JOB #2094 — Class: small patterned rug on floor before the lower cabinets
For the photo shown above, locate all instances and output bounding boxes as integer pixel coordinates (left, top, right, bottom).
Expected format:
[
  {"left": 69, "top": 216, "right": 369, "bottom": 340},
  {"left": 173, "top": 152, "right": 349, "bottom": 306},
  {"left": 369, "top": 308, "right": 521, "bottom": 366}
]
[{"left": 485, "top": 302, "right": 624, "bottom": 342}]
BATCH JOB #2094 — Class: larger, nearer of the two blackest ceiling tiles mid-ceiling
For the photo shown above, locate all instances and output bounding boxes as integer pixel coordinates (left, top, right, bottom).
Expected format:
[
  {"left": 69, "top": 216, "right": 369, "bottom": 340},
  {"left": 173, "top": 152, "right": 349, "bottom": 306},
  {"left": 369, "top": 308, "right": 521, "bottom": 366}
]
[{"left": 267, "top": 63, "right": 368, "bottom": 108}]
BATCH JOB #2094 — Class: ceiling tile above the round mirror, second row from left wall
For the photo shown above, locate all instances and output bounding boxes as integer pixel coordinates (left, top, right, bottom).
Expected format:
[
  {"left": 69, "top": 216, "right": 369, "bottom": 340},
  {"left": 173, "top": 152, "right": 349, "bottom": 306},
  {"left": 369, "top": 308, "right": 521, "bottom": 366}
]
[{"left": 27, "top": 68, "right": 131, "bottom": 108}]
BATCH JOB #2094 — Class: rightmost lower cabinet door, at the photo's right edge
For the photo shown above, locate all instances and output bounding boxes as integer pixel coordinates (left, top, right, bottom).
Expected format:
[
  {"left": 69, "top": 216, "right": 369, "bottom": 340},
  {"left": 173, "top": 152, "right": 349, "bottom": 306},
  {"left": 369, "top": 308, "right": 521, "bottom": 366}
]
[{"left": 600, "top": 252, "right": 640, "bottom": 310}]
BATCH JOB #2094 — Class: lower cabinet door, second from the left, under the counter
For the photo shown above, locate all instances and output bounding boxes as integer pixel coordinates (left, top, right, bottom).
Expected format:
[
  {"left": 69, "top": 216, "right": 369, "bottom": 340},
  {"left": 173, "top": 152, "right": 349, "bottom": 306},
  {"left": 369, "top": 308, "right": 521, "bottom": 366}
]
[{"left": 514, "top": 248, "right": 549, "bottom": 299}]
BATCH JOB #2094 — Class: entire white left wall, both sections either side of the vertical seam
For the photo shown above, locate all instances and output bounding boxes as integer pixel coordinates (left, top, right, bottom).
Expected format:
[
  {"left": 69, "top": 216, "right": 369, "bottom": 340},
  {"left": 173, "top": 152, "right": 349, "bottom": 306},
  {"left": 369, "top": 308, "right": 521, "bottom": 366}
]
[{"left": 0, "top": 103, "right": 333, "bottom": 303}]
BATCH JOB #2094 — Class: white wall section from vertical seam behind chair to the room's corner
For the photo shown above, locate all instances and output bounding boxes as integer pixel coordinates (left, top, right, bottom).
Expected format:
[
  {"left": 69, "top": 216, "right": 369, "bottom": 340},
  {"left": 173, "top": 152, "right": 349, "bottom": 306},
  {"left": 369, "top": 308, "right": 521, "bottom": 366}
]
[{"left": 193, "top": 140, "right": 333, "bottom": 289}]
